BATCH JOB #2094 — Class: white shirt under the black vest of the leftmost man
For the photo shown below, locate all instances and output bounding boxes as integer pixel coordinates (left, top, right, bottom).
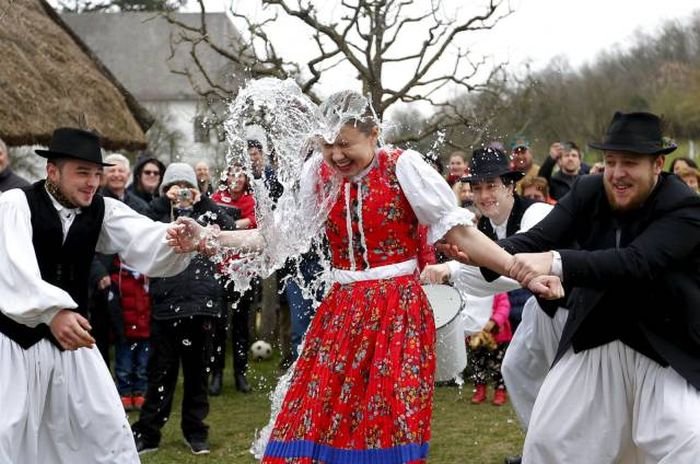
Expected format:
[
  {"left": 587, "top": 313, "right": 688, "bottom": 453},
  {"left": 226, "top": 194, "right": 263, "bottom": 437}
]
[{"left": 0, "top": 189, "right": 192, "bottom": 327}]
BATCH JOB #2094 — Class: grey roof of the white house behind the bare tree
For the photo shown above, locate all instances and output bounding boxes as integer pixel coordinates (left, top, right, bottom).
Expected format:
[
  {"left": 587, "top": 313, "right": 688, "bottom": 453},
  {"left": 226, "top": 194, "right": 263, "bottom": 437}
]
[{"left": 64, "top": 12, "right": 248, "bottom": 103}]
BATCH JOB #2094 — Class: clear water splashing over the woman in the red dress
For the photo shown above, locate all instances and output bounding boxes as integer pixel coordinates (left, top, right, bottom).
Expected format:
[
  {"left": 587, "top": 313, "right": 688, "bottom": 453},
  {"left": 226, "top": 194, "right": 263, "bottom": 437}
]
[{"left": 208, "top": 78, "right": 335, "bottom": 295}]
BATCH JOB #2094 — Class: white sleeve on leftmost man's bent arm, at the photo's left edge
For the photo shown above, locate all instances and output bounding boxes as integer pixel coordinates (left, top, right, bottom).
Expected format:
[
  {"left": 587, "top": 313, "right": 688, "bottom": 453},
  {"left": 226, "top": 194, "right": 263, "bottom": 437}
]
[{"left": 0, "top": 189, "right": 78, "bottom": 327}]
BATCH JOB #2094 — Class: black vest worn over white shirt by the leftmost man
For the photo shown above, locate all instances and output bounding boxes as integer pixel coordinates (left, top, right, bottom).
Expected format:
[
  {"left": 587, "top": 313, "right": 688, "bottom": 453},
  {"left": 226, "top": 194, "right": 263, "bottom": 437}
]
[{"left": 0, "top": 180, "right": 105, "bottom": 349}]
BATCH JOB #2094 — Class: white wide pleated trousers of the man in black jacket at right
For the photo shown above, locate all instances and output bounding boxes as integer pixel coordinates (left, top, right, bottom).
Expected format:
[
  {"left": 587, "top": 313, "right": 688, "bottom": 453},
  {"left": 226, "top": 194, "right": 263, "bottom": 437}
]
[{"left": 523, "top": 341, "right": 700, "bottom": 464}]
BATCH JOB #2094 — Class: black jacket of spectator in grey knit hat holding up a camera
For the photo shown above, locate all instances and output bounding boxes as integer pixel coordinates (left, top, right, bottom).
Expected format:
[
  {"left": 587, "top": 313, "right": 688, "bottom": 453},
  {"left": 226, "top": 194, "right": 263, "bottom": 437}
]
[{"left": 149, "top": 196, "right": 235, "bottom": 320}]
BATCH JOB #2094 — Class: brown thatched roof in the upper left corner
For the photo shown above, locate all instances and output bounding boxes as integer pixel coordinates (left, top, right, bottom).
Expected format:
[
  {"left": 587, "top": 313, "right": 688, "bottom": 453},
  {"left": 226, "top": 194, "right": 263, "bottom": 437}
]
[{"left": 0, "top": 0, "right": 153, "bottom": 150}]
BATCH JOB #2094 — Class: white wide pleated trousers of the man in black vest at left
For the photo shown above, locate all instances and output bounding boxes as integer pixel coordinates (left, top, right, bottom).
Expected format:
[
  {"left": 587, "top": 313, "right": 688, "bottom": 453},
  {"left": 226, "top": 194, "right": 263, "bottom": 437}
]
[{"left": 0, "top": 333, "right": 140, "bottom": 464}]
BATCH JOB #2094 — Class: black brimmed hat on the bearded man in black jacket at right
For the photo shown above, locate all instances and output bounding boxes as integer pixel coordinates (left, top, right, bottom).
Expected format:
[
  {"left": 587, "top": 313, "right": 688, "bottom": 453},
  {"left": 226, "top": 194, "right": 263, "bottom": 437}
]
[{"left": 588, "top": 111, "right": 677, "bottom": 155}]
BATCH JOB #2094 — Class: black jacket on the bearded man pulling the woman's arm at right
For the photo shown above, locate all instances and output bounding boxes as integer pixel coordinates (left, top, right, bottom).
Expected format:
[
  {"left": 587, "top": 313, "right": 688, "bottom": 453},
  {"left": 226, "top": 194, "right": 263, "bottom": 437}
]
[{"left": 492, "top": 173, "right": 700, "bottom": 389}]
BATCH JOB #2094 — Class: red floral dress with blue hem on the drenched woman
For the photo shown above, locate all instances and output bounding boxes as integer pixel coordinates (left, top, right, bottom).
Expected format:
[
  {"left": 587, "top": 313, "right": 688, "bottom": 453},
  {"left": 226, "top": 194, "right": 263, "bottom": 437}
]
[{"left": 262, "top": 150, "right": 435, "bottom": 464}]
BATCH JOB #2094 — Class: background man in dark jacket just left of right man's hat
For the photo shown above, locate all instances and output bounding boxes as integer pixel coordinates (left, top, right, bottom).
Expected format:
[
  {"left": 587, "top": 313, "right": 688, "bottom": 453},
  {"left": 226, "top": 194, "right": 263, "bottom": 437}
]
[{"left": 539, "top": 142, "right": 584, "bottom": 201}]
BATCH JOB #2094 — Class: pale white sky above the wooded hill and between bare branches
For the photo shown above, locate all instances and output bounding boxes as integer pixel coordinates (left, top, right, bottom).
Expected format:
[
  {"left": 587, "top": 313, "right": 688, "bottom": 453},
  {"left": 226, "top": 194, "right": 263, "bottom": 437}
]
[{"left": 187, "top": 0, "right": 700, "bottom": 112}]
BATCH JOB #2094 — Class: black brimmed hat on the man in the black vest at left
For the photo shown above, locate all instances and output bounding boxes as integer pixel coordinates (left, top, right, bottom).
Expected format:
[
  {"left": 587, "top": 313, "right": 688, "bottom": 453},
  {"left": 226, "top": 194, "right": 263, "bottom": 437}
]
[{"left": 35, "top": 127, "right": 113, "bottom": 166}]
